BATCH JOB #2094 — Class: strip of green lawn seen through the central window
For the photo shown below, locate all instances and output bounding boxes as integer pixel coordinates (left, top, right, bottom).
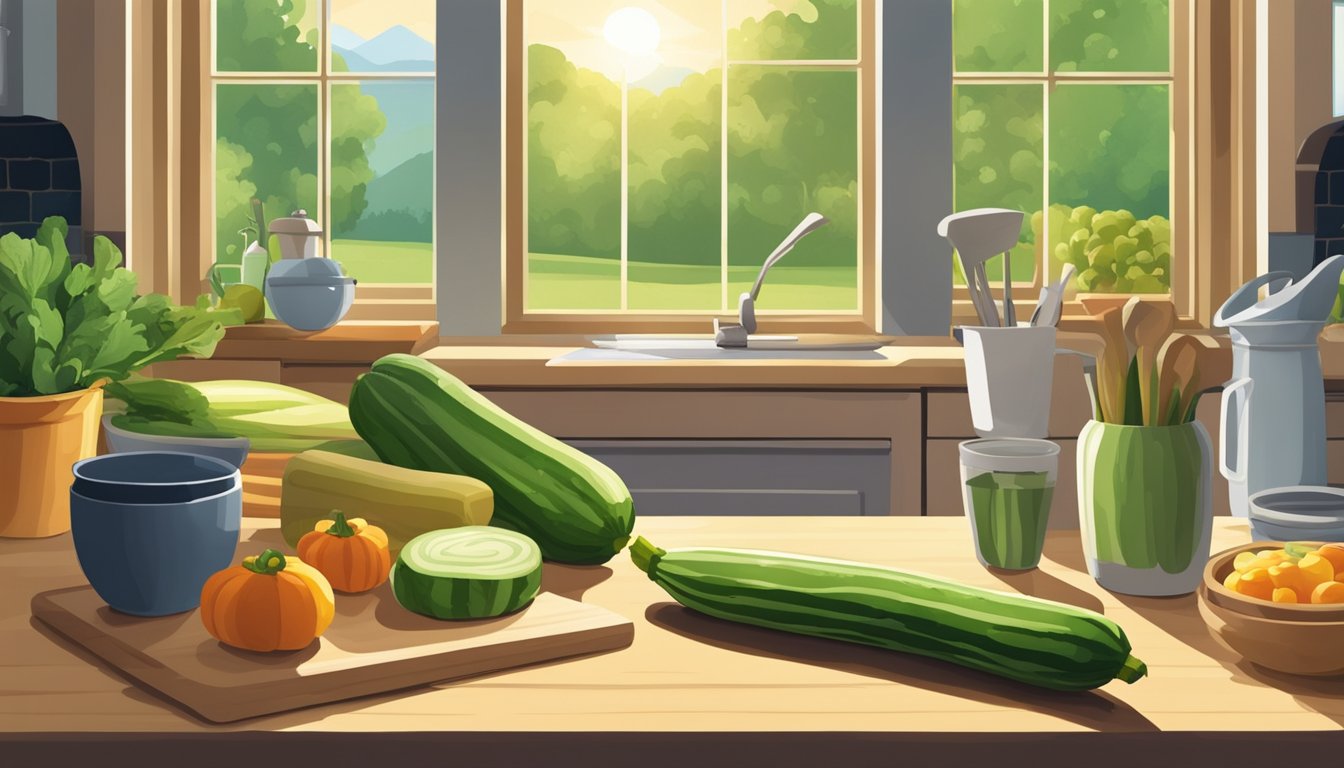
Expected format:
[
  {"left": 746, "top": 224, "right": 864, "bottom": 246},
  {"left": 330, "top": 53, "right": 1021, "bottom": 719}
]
[{"left": 527, "top": 253, "right": 859, "bottom": 311}]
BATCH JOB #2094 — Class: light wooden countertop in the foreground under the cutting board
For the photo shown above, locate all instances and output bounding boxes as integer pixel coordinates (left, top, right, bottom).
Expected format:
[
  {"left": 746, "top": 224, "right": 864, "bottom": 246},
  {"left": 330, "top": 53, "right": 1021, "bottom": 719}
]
[{"left": 0, "top": 518, "right": 1344, "bottom": 767}]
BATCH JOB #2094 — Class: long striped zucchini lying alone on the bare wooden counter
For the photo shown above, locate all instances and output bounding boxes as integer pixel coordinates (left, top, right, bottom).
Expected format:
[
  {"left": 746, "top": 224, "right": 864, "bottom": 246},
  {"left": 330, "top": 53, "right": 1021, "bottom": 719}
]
[{"left": 630, "top": 537, "right": 1148, "bottom": 690}]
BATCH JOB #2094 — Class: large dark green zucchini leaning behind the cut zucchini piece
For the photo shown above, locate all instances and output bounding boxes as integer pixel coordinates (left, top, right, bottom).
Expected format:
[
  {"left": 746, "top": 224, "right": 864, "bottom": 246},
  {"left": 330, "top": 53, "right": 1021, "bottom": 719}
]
[{"left": 349, "top": 355, "right": 634, "bottom": 565}]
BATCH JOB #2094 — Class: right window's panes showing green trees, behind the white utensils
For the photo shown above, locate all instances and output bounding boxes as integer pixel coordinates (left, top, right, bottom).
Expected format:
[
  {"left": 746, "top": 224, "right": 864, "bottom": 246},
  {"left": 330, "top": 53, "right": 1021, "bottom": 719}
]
[{"left": 953, "top": 0, "right": 1188, "bottom": 297}]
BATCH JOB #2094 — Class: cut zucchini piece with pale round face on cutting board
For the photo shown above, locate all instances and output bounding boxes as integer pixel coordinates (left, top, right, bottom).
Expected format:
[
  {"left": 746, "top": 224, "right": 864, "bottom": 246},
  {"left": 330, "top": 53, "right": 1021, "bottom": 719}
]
[{"left": 391, "top": 526, "right": 542, "bottom": 619}]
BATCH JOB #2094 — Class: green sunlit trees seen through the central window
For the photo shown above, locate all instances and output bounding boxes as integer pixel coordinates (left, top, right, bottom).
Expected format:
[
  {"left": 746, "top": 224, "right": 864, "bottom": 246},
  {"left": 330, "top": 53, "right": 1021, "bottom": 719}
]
[{"left": 528, "top": 0, "right": 859, "bottom": 307}]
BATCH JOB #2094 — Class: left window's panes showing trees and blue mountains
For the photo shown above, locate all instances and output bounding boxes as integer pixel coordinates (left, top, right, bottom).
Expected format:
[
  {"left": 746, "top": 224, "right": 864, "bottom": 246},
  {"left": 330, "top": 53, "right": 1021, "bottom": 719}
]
[{"left": 210, "top": 0, "right": 435, "bottom": 317}]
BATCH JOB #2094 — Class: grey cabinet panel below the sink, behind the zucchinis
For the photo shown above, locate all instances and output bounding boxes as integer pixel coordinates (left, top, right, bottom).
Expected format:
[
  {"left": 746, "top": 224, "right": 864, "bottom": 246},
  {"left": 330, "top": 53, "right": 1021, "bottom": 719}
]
[{"left": 566, "top": 440, "right": 891, "bottom": 515}]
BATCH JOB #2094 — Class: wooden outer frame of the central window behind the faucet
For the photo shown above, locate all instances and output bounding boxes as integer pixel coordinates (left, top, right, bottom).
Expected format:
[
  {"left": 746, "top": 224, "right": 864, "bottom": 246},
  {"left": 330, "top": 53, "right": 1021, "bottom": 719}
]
[{"left": 501, "top": 0, "right": 882, "bottom": 334}]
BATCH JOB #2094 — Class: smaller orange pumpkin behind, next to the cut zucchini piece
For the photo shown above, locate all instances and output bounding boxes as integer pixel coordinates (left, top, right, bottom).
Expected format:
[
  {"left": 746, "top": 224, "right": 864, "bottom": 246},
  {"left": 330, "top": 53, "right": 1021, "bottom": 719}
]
[{"left": 297, "top": 510, "right": 392, "bottom": 592}]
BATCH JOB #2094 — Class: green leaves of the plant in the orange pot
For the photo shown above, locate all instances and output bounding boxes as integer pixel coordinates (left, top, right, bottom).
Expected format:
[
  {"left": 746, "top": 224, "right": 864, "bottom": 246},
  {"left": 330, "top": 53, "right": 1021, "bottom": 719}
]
[{"left": 0, "top": 217, "right": 242, "bottom": 397}]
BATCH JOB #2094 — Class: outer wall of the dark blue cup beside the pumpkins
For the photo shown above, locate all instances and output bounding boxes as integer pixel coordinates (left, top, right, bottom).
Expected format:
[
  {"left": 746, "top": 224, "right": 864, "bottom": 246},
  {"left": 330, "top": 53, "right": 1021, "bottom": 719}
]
[{"left": 70, "top": 477, "right": 243, "bottom": 616}]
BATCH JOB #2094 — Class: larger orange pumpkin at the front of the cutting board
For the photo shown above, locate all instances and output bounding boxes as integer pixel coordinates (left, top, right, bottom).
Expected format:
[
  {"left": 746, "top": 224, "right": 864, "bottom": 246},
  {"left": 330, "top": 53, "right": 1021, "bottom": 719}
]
[{"left": 200, "top": 549, "right": 336, "bottom": 651}]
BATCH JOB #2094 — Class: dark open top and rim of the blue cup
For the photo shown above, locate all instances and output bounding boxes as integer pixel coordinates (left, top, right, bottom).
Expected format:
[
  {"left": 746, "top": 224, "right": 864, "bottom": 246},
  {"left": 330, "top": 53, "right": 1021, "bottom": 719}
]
[{"left": 70, "top": 451, "right": 239, "bottom": 504}]
